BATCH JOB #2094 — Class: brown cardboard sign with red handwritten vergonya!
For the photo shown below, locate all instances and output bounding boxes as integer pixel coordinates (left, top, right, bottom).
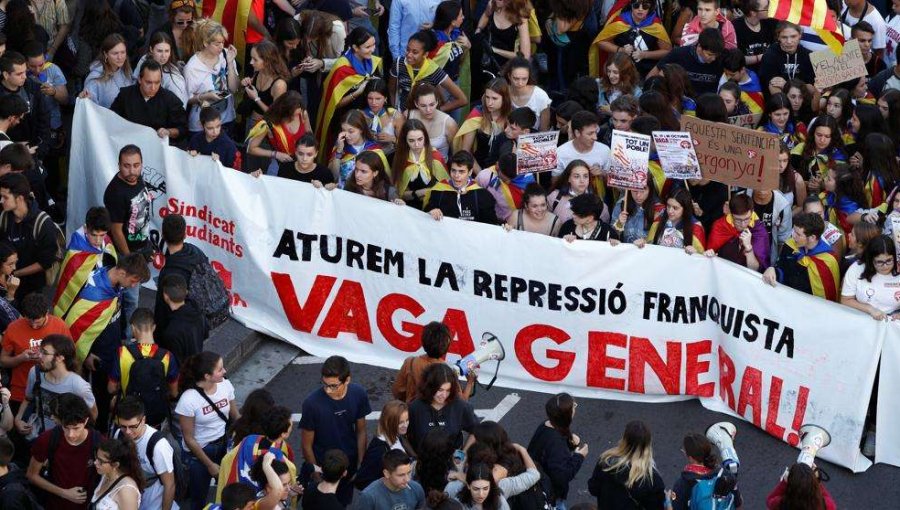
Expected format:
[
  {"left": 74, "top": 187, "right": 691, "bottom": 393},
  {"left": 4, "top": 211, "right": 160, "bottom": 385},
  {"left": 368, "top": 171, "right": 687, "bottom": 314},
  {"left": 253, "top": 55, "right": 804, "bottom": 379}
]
[{"left": 681, "top": 115, "right": 779, "bottom": 190}]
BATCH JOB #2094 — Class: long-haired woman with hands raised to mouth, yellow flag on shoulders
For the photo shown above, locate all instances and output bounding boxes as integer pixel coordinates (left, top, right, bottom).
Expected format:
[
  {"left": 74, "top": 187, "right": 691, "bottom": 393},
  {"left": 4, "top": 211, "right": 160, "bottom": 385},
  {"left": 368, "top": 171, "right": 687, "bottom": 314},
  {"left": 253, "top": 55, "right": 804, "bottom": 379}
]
[{"left": 393, "top": 119, "right": 450, "bottom": 209}]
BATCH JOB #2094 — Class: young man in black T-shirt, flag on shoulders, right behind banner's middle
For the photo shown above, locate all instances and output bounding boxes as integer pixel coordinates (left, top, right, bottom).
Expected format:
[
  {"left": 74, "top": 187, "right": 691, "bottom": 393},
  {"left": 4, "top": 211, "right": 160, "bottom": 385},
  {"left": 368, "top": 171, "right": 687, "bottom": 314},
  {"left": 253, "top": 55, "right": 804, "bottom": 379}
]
[{"left": 424, "top": 150, "right": 500, "bottom": 225}]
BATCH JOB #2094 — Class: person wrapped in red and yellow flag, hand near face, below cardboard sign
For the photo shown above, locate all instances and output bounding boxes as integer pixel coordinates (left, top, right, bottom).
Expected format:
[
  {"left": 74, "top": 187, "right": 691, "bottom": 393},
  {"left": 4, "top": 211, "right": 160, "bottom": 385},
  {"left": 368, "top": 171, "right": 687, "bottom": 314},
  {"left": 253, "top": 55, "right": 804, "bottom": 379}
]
[{"left": 704, "top": 194, "right": 769, "bottom": 271}]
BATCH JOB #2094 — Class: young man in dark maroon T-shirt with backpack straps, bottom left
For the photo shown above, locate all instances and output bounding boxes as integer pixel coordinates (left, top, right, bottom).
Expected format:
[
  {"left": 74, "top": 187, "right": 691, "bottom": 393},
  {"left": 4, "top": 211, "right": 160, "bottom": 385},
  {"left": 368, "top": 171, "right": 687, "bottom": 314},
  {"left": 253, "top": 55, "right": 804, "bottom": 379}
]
[{"left": 26, "top": 393, "right": 103, "bottom": 510}]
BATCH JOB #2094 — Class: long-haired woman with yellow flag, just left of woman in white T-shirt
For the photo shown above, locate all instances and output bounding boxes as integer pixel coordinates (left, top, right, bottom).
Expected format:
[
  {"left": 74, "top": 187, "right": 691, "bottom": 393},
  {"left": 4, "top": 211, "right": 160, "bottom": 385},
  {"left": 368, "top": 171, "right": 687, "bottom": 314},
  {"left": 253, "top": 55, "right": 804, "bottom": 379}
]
[{"left": 453, "top": 78, "right": 512, "bottom": 168}]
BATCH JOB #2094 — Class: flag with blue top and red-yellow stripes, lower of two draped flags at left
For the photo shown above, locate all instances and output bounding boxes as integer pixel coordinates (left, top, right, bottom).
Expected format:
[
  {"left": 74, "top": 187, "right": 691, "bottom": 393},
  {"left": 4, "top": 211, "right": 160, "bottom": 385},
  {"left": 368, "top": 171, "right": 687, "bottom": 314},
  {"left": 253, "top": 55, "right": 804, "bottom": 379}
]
[{"left": 63, "top": 267, "right": 121, "bottom": 363}]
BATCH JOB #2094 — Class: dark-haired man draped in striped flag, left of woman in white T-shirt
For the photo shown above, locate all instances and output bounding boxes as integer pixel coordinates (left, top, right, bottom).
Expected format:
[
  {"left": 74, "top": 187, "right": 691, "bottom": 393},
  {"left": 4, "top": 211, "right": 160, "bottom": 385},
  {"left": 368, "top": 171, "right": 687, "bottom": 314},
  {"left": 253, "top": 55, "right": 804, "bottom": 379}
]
[{"left": 763, "top": 213, "right": 841, "bottom": 301}]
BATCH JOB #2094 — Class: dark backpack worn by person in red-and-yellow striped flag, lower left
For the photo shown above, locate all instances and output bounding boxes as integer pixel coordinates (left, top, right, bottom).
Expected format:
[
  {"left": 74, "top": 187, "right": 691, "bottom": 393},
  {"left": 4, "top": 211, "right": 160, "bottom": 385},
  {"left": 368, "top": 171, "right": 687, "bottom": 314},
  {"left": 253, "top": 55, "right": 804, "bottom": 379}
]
[{"left": 123, "top": 344, "right": 170, "bottom": 426}]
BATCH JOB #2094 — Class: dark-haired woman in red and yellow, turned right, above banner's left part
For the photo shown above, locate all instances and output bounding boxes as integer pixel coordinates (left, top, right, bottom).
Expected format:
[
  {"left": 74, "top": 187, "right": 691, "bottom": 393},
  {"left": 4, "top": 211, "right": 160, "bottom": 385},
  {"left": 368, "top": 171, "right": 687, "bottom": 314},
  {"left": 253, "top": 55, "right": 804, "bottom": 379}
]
[{"left": 247, "top": 90, "right": 312, "bottom": 175}]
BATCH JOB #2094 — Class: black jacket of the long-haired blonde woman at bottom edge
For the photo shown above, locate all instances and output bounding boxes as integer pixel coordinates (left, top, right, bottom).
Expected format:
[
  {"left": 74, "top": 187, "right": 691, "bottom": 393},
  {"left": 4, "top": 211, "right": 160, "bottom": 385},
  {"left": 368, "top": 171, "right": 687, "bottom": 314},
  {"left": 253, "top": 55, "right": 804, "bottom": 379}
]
[{"left": 588, "top": 463, "right": 666, "bottom": 510}]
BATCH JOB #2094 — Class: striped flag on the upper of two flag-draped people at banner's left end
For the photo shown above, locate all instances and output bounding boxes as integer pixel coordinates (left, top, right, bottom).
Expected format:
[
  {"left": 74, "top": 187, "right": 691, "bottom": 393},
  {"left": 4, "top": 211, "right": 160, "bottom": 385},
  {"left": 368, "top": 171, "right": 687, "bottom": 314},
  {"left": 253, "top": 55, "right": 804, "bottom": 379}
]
[{"left": 53, "top": 227, "right": 117, "bottom": 317}]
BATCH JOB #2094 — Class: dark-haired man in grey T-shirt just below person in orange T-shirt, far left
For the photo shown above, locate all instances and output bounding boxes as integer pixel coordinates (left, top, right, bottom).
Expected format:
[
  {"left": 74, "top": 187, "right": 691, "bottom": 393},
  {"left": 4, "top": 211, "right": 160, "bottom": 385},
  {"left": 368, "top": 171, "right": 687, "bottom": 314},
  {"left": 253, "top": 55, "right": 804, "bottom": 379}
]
[{"left": 16, "top": 334, "right": 97, "bottom": 437}]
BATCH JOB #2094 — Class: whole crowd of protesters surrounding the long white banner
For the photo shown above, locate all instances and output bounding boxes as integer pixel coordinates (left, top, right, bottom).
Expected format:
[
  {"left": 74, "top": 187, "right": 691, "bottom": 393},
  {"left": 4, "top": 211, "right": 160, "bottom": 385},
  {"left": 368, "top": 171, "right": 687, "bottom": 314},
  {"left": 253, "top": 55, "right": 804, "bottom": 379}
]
[{"left": 0, "top": 0, "right": 900, "bottom": 510}]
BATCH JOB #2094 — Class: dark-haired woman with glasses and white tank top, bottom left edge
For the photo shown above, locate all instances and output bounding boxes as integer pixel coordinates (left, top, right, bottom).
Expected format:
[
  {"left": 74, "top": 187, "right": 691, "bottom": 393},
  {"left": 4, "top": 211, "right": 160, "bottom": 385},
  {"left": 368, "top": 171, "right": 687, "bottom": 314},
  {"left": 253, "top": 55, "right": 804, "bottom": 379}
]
[{"left": 91, "top": 434, "right": 144, "bottom": 510}]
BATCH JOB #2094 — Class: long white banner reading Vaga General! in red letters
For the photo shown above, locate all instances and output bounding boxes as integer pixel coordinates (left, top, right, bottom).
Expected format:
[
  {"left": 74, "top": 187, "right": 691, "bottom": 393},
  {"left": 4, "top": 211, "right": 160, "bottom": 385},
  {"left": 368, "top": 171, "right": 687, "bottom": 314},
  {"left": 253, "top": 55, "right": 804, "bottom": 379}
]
[{"left": 68, "top": 100, "right": 900, "bottom": 471}]
